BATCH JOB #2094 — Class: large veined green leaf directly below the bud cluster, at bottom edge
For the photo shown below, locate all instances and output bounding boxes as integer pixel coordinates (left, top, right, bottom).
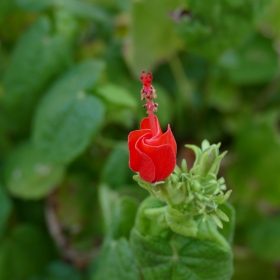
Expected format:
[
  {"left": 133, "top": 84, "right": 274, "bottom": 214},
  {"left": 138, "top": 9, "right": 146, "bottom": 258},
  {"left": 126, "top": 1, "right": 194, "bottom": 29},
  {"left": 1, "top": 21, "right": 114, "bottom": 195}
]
[{"left": 130, "top": 198, "right": 232, "bottom": 279}]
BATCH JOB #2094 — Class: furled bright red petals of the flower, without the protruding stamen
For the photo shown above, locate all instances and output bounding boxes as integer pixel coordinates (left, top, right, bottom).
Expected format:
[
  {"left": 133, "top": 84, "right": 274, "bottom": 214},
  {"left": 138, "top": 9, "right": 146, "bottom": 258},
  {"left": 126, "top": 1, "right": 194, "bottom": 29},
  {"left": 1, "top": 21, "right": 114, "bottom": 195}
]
[{"left": 128, "top": 116, "right": 177, "bottom": 183}]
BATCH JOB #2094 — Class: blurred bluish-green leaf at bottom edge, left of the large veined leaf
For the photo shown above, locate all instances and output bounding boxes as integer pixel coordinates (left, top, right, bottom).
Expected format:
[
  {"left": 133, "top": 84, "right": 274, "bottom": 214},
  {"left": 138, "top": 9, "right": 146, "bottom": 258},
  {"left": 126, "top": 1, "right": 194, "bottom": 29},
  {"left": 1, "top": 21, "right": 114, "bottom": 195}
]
[{"left": 91, "top": 238, "right": 139, "bottom": 280}]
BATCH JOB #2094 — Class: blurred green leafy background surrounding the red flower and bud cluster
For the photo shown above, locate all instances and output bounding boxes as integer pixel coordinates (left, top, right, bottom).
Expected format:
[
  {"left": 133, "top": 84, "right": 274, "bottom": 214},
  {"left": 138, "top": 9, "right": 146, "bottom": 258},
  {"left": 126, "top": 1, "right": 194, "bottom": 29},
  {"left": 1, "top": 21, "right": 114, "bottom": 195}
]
[{"left": 0, "top": 0, "right": 280, "bottom": 280}]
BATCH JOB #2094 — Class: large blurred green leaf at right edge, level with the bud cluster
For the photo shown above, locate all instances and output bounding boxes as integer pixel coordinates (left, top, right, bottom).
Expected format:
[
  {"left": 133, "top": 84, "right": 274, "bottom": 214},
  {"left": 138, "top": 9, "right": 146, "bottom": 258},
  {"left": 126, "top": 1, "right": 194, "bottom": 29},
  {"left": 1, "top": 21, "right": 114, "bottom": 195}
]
[{"left": 227, "top": 115, "right": 280, "bottom": 205}]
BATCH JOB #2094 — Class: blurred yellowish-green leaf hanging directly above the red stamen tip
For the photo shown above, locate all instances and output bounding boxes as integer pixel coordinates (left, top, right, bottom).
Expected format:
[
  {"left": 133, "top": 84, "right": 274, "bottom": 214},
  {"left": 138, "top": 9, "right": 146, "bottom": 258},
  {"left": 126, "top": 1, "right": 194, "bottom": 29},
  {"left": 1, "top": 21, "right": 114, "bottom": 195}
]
[{"left": 125, "top": 0, "right": 182, "bottom": 76}]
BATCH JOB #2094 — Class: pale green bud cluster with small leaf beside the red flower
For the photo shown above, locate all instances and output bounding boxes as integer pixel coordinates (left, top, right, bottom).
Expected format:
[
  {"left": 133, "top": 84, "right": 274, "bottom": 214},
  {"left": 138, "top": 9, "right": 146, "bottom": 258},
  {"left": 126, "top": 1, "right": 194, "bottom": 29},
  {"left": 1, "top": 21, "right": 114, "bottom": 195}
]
[{"left": 134, "top": 140, "right": 231, "bottom": 236}]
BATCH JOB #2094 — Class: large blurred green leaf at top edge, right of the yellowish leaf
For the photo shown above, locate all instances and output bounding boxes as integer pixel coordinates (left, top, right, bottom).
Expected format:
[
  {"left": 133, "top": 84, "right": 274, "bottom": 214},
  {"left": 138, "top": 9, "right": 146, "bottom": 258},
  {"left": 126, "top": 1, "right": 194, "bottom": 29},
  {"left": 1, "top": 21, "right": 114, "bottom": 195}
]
[{"left": 178, "top": 0, "right": 269, "bottom": 59}]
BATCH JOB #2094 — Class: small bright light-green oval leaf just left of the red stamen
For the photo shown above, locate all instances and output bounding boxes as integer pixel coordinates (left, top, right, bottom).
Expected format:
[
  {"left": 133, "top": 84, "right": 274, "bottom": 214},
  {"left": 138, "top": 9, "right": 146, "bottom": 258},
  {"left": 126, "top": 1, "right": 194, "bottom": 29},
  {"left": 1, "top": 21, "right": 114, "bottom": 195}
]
[{"left": 95, "top": 84, "right": 137, "bottom": 109}]
